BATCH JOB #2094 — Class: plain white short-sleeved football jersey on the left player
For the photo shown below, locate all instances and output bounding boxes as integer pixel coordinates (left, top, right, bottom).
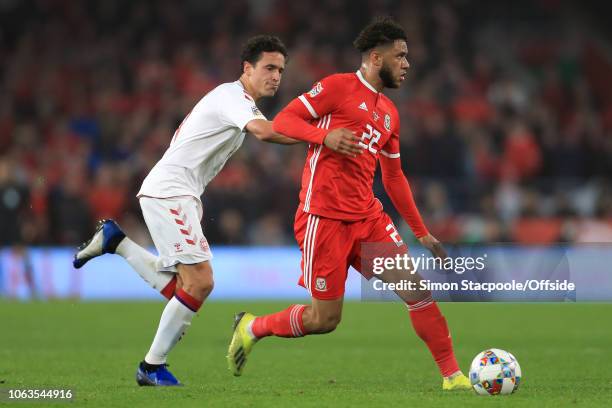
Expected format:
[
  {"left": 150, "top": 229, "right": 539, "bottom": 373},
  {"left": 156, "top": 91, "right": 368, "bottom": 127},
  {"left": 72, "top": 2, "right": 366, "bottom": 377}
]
[{"left": 138, "top": 81, "right": 266, "bottom": 199}]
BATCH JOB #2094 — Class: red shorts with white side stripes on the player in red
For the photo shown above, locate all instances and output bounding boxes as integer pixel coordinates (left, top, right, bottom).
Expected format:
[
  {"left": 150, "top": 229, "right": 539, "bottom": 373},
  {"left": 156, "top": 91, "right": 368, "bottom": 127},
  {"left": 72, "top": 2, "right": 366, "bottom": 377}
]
[{"left": 294, "top": 208, "right": 408, "bottom": 300}]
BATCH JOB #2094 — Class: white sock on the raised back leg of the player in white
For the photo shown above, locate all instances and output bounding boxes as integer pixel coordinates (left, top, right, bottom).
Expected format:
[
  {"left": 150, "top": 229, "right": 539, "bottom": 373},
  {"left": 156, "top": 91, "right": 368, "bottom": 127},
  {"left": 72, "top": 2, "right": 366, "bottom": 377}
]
[{"left": 115, "top": 237, "right": 175, "bottom": 292}]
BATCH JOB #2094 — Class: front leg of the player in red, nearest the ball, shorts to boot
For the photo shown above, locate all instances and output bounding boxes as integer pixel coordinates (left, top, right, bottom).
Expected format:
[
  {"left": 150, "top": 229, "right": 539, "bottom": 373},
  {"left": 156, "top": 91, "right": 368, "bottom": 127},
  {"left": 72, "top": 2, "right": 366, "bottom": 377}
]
[{"left": 353, "top": 213, "right": 471, "bottom": 389}]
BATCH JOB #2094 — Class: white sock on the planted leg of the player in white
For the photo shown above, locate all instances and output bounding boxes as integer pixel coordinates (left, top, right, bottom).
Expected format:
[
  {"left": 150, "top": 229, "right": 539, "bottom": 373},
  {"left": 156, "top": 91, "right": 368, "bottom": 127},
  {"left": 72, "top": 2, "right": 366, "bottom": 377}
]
[{"left": 145, "top": 297, "right": 195, "bottom": 364}]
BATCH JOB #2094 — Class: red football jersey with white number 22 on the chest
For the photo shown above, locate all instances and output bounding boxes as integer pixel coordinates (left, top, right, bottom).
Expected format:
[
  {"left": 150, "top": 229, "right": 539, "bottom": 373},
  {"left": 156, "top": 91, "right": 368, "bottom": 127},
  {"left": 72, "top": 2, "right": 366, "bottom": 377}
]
[{"left": 298, "top": 71, "right": 400, "bottom": 221}]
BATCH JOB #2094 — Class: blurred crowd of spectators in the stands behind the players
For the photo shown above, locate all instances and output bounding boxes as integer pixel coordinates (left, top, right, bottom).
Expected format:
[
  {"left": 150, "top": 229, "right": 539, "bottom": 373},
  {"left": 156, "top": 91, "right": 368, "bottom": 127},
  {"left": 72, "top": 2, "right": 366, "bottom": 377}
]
[{"left": 0, "top": 0, "right": 612, "bottom": 245}]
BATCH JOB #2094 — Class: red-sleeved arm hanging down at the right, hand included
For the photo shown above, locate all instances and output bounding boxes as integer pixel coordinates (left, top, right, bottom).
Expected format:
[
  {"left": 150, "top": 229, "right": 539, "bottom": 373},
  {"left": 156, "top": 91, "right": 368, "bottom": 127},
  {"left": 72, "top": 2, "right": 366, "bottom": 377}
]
[{"left": 380, "top": 143, "right": 447, "bottom": 259}]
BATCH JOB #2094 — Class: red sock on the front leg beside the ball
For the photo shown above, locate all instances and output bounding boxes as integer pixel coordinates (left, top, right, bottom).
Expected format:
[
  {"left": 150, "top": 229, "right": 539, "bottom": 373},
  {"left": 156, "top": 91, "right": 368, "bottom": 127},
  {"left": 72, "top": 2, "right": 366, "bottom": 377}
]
[{"left": 408, "top": 297, "right": 459, "bottom": 377}]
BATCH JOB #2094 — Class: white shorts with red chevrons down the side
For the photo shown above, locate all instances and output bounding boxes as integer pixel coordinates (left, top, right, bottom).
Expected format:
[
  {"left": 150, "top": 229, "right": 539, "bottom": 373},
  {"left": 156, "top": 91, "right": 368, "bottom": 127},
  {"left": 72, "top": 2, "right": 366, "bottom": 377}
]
[{"left": 140, "top": 196, "right": 212, "bottom": 272}]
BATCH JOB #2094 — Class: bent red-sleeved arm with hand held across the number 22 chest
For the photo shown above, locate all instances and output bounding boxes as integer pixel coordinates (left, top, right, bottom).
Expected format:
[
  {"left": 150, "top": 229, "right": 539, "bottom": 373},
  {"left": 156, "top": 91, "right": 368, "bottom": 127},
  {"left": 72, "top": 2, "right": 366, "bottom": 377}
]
[{"left": 274, "top": 76, "right": 363, "bottom": 157}]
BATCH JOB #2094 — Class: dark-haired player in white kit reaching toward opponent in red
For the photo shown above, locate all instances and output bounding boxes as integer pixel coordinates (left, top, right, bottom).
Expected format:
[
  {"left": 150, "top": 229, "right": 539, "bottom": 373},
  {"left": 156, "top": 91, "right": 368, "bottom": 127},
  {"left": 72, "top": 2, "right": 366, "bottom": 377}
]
[{"left": 74, "top": 36, "right": 297, "bottom": 386}]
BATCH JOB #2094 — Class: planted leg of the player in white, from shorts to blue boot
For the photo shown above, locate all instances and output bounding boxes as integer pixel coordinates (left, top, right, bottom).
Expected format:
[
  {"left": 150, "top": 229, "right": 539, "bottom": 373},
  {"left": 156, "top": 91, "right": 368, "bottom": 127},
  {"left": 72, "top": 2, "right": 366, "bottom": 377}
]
[{"left": 136, "top": 197, "right": 213, "bottom": 385}]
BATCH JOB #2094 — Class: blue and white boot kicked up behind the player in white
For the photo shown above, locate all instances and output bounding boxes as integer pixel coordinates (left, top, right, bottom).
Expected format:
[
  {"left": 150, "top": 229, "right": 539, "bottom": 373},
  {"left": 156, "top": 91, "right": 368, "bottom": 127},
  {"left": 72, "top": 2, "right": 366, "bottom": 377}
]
[{"left": 72, "top": 220, "right": 125, "bottom": 269}]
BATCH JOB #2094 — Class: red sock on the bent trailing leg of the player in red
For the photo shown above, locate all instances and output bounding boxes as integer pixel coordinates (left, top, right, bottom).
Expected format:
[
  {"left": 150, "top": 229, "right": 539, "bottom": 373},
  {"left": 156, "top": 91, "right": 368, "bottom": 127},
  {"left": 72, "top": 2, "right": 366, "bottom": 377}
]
[{"left": 251, "top": 305, "right": 306, "bottom": 338}]
